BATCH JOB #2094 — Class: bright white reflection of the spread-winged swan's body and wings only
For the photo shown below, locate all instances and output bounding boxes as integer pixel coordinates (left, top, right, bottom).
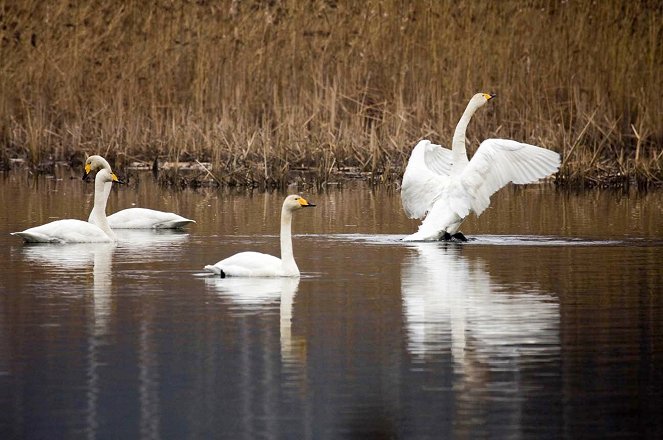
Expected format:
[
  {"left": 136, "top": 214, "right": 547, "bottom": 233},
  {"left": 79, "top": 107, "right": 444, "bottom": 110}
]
[{"left": 401, "top": 243, "right": 559, "bottom": 364}]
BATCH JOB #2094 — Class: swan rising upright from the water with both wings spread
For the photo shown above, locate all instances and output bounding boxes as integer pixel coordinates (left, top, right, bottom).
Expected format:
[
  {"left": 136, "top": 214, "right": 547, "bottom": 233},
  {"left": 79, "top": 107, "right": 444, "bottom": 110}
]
[{"left": 401, "top": 93, "right": 560, "bottom": 241}]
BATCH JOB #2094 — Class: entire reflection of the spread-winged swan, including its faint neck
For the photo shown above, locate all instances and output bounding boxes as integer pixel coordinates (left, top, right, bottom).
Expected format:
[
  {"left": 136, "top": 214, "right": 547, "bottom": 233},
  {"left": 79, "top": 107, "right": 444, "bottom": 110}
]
[{"left": 402, "top": 243, "right": 560, "bottom": 430}]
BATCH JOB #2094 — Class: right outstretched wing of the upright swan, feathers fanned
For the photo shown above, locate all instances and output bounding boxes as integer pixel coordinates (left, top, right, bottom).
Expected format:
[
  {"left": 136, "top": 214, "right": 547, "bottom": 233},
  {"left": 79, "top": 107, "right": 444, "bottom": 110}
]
[{"left": 459, "top": 139, "right": 560, "bottom": 215}]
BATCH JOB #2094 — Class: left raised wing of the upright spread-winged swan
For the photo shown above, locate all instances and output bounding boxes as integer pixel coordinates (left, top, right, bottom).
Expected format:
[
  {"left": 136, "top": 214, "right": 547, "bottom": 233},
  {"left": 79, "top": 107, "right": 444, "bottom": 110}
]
[{"left": 401, "top": 140, "right": 451, "bottom": 218}]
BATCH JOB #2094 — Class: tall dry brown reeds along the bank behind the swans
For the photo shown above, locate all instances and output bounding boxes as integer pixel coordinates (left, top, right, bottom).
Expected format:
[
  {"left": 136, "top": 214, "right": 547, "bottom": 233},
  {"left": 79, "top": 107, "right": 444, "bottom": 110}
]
[{"left": 0, "top": 0, "right": 663, "bottom": 188}]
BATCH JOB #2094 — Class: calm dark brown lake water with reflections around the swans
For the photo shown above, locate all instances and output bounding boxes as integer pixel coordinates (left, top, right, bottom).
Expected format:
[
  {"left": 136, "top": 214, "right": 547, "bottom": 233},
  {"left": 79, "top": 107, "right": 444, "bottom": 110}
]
[{"left": 0, "top": 172, "right": 663, "bottom": 439}]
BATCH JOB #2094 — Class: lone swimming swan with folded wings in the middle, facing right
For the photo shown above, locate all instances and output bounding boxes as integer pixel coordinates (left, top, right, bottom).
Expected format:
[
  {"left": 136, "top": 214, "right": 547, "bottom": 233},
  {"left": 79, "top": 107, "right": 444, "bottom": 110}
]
[{"left": 205, "top": 195, "right": 315, "bottom": 278}]
